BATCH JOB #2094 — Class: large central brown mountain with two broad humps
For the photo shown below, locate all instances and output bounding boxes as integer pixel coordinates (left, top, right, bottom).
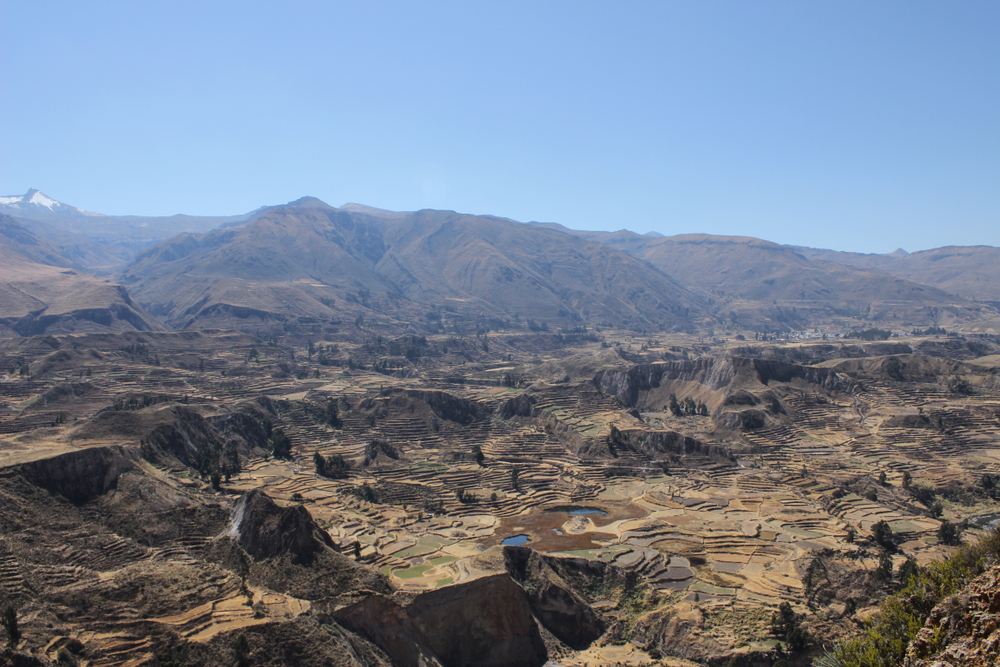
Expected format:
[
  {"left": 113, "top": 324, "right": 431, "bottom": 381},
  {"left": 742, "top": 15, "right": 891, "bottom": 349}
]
[{"left": 123, "top": 198, "right": 702, "bottom": 328}]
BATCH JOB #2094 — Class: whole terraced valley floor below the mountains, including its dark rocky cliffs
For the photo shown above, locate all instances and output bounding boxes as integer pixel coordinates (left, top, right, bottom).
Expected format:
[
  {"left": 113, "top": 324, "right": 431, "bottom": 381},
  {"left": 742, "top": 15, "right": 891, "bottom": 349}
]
[{"left": 0, "top": 330, "right": 1000, "bottom": 665}]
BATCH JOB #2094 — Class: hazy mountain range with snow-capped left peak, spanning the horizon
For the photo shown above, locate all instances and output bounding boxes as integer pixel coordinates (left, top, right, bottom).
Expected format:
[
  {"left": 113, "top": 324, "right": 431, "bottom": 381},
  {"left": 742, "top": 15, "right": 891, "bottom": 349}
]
[{"left": 0, "top": 190, "right": 1000, "bottom": 331}]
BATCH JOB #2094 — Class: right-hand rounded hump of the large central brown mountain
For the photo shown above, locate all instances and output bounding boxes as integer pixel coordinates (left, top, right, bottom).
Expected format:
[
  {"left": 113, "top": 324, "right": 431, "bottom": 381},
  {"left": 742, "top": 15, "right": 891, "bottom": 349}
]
[{"left": 379, "top": 211, "right": 702, "bottom": 327}]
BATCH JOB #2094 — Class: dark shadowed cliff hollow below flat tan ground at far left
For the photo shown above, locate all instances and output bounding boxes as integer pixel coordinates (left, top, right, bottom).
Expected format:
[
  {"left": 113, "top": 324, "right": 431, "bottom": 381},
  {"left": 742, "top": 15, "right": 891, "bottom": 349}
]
[{"left": 16, "top": 446, "right": 139, "bottom": 503}]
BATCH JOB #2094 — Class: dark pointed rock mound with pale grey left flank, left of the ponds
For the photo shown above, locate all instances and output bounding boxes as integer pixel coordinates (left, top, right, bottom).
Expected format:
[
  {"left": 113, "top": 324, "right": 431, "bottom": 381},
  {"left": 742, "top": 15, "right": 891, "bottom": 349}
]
[{"left": 227, "top": 489, "right": 334, "bottom": 565}]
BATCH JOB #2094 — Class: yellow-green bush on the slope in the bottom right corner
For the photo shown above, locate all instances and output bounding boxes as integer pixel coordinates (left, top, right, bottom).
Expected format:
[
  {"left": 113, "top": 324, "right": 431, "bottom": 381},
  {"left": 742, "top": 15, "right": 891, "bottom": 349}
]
[{"left": 814, "top": 528, "right": 1000, "bottom": 667}]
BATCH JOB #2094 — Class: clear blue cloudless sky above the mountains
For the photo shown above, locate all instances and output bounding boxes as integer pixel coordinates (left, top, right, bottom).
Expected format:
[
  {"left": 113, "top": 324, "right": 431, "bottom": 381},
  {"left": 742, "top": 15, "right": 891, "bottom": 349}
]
[{"left": 0, "top": 0, "right": 1000, "bottom": 252}]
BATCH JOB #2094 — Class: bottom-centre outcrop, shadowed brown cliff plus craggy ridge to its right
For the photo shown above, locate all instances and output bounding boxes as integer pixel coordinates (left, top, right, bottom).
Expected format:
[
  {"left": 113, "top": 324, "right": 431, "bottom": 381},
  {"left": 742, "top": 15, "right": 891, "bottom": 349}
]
[{"left": 333, "top": 547, "right": 620, "bottom": 667}]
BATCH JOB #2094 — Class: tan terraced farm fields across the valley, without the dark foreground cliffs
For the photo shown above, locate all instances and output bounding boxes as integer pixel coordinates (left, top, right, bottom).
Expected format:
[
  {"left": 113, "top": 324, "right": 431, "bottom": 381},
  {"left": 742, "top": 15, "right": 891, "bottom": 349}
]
[{"left": 0, "top": 332, "right": 1000, "bottom": 665}]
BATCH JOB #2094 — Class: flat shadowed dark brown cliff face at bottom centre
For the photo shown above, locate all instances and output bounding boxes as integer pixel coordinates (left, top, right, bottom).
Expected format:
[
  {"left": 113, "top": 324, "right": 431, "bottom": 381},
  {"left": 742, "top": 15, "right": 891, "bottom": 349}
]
[{"left": 333, "top": 573, "right": 547, "bottom": 667}]
